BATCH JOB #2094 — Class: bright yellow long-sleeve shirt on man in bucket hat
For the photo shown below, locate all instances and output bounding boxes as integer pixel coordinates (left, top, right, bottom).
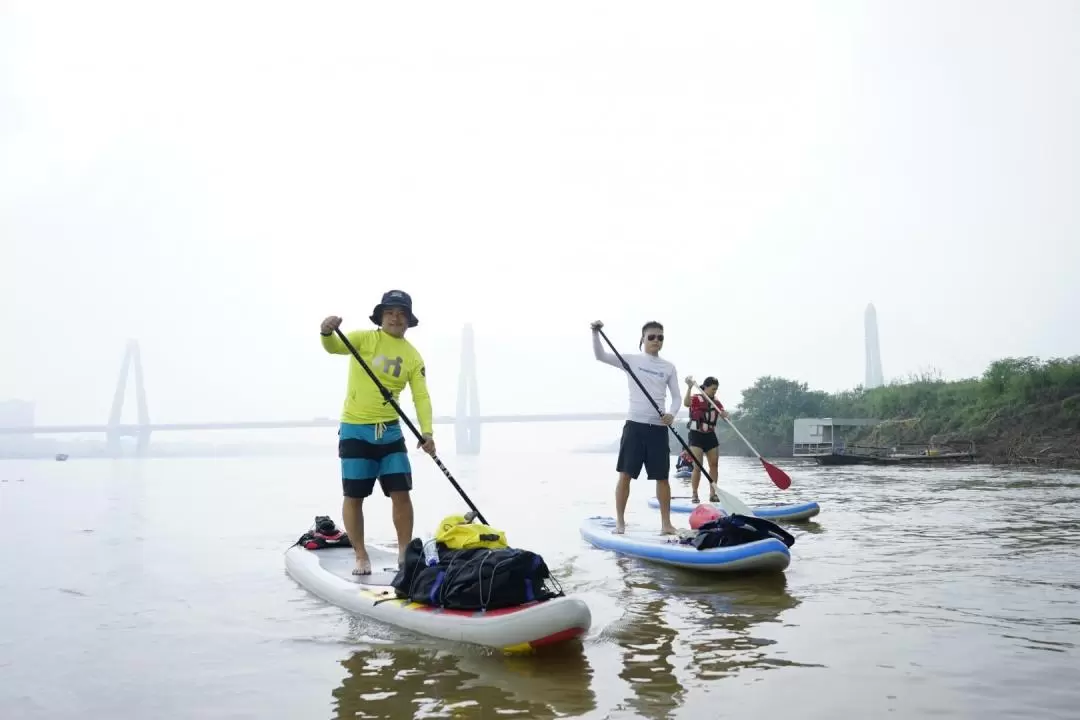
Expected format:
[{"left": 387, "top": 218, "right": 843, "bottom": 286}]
[{"left": 320, "top": 329, "right": 432, "bottom": 433}]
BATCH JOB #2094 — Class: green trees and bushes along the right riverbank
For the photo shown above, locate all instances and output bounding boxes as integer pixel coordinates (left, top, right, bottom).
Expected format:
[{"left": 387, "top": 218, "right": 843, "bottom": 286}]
[{"left": 720, "top": 355, "right": 1080, "bottom": 466}]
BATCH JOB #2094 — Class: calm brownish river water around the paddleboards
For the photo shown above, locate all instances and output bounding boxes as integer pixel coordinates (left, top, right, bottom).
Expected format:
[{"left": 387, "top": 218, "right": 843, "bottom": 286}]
[{"left": 0, "top": 427, "right": 1080, "bottom": 720}]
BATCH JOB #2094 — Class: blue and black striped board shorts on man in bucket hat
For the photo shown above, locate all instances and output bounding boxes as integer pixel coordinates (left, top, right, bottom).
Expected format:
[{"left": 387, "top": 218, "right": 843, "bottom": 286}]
[{"left": 338, "top": 420, "right": 413, "bottom": 498}]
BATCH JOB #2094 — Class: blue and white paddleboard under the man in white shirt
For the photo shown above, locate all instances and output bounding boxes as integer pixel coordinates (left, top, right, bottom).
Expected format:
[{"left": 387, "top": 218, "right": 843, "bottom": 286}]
[{"left": 581, "top": 516, "right": 792, "bottom": 572}]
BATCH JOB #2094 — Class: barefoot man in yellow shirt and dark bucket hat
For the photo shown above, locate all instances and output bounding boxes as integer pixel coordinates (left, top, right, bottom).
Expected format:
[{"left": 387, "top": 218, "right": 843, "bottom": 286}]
[{"left": 320, "top": 290, "right": 435, "bottom": 575}]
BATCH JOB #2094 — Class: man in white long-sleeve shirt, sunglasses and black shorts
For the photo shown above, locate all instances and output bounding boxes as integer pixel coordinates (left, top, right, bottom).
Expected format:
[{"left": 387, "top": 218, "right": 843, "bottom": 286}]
[{"left": 592, "top": 321, "right": 683, "bottom": 534}]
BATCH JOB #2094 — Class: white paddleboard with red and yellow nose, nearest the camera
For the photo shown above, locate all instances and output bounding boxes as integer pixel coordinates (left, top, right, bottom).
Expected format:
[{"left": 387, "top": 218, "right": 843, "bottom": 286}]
[{"left": 285, "top": 545, "right": 592, "bottom": 654}]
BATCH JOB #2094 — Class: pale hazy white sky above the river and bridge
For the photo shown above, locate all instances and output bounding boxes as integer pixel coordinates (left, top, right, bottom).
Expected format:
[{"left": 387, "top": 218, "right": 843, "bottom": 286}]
[{"left": 0, "top": 0, "right": 1080, "bottom": 423}]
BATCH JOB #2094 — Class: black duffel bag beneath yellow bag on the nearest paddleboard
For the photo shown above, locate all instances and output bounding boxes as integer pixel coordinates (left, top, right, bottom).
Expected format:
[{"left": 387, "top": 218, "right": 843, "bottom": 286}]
[{"left": 393, "top": 538, "right": 564, "bottom": 610}]
